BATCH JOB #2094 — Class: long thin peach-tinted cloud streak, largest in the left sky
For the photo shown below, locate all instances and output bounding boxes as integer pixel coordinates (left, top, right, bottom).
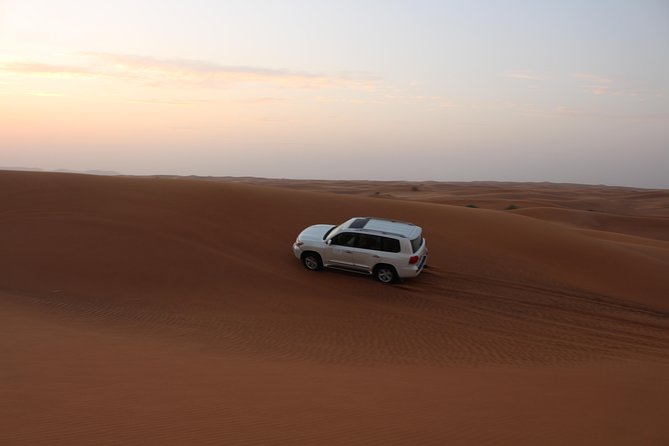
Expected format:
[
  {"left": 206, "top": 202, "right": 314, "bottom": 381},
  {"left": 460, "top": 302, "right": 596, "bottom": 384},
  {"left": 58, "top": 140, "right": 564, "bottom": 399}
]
[{"left": 0, "top": 52, "right": 378, "bottom": 89}]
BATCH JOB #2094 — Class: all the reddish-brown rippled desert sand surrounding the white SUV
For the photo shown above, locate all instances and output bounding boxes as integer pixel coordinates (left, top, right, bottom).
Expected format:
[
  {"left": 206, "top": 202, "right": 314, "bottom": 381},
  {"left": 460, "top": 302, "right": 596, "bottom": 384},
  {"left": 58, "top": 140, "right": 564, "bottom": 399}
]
[{"left": 0, "top": 171, "right": 669, "bottom": 445}]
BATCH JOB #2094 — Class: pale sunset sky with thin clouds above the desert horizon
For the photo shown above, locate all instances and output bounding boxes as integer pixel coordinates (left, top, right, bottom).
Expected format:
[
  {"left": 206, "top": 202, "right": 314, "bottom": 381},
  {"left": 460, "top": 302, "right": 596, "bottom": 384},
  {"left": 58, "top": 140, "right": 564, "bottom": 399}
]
[{"left": 0, "top": 0, "right": 669, "bottom": 188}]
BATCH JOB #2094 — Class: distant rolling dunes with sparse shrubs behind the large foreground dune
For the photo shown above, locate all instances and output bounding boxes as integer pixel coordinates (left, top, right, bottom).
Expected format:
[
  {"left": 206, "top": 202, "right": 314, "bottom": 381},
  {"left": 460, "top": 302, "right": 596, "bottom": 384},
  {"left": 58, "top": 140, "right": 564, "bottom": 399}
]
[{"left": 207, "top": 177, "right": 669, "bottom": 240}]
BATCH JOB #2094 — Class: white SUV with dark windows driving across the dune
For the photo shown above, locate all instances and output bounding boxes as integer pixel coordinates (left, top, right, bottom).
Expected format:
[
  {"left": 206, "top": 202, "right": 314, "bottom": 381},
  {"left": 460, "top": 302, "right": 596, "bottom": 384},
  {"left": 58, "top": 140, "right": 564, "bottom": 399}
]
[{"left": 293, "top": 217, "right": 427, "bottom": 283}]
